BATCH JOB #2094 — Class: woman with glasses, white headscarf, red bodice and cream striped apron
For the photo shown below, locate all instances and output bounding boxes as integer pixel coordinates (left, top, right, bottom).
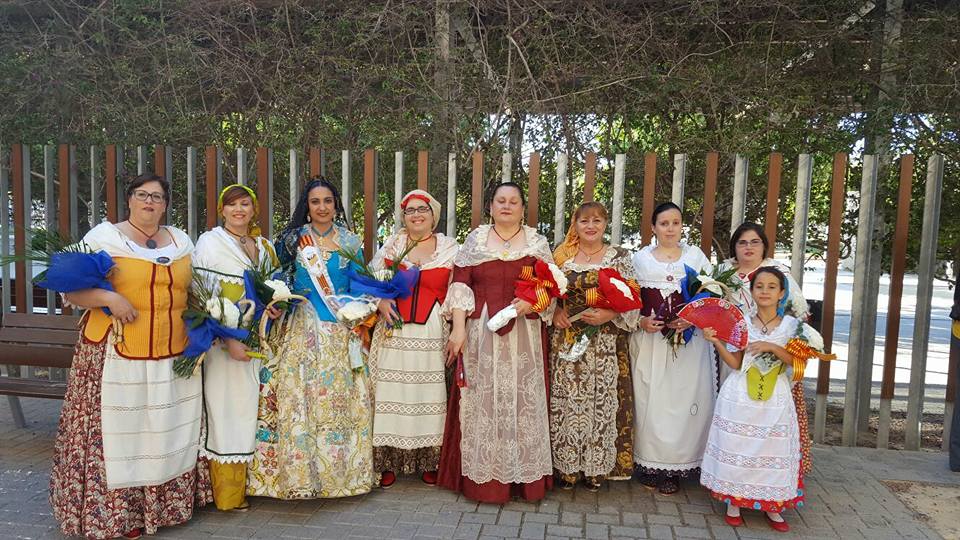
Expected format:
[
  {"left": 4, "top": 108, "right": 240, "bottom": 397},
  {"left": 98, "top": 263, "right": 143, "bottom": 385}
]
[{"left": 368, "top": 189, "right": 459, "bottom": 488}]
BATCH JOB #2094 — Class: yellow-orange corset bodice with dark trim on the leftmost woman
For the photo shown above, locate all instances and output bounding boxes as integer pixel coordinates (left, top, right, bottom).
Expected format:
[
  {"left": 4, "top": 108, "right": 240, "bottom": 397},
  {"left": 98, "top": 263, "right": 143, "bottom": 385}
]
[{"left": 83, "top": 257, "right": 192, "bottom": 360}]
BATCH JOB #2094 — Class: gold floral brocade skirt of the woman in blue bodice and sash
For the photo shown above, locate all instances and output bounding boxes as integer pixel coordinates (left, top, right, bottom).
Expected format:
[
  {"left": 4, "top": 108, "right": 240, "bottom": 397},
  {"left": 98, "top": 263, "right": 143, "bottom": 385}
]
[{"left": 247, "top": 303, "right": 375, "bottom": 499}]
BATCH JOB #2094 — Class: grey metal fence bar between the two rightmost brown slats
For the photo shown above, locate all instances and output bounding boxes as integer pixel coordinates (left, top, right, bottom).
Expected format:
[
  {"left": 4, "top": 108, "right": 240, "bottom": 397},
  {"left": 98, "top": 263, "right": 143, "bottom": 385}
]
[{"left": 843, "top": 154, "right": 879, "bottom": 446}]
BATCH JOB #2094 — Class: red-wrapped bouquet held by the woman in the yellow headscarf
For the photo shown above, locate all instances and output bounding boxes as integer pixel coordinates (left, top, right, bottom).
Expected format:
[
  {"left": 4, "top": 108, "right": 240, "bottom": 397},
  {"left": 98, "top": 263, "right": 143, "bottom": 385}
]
[{"left": 559, "top": 268, "right": 643, "bottom": 362}]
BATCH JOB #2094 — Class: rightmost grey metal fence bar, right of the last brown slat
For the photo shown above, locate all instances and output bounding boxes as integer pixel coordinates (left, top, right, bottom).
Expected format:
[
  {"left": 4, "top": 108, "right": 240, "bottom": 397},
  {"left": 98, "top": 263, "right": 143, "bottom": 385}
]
[{"left": 904, "top": 154, "right": 943, "bottom": 450}]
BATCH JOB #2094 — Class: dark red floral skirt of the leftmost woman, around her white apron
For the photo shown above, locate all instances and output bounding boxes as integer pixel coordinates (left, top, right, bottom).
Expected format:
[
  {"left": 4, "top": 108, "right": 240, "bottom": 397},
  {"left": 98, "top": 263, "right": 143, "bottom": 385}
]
[{"left": 50, "top": 337, "right": 213, "bottom": 538}]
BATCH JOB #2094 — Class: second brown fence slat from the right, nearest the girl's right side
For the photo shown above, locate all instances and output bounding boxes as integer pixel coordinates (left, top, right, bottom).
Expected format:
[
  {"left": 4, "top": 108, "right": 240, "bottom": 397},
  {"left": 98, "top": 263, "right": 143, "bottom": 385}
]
[{"left": 813, "top": 153, "right": 847, "bottom": 443}]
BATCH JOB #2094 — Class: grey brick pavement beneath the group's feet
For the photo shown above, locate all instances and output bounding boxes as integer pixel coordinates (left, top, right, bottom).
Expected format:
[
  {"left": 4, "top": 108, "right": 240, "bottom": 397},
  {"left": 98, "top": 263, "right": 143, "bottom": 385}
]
[{"left": 0, "top": 398, "right": 960, "bottom": 540}]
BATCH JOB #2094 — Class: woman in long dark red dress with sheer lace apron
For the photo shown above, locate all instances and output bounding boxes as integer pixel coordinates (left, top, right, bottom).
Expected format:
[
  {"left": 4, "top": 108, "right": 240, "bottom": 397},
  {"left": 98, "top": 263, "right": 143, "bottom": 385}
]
[{"left": 438, "top": 182, "right": 554, "bottom": 503}]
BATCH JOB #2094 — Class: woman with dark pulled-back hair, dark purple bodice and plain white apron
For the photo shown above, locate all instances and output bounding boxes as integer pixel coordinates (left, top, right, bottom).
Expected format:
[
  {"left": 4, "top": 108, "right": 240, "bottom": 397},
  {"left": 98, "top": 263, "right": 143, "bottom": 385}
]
[{"left": 630, "top": 202, "right": 717, "bottom": 495}]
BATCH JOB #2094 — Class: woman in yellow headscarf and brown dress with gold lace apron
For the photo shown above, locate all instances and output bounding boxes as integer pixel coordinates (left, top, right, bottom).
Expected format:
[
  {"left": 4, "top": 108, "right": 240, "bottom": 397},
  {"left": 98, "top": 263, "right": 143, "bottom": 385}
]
[{"left": 550, "top": 202, "right": 640, "bottom": 491}]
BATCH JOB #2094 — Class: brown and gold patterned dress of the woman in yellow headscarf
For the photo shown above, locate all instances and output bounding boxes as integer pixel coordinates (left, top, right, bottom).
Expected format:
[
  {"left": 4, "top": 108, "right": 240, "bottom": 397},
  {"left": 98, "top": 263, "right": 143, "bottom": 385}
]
[{"left": 550, "top": 247, "right": 638, "bottom": 478}]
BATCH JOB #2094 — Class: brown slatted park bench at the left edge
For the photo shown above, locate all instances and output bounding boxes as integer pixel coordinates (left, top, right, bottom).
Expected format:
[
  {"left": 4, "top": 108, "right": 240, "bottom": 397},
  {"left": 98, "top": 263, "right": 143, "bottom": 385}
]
[{"left": 0, "top": 313, "right": 80, "bottom": 427}]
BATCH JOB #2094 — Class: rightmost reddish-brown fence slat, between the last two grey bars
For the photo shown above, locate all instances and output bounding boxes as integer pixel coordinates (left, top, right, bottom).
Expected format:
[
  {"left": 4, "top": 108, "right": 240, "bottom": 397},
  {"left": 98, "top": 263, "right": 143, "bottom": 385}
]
[{"left": 877, "top": 154, "right": 916, "bottom": 448}]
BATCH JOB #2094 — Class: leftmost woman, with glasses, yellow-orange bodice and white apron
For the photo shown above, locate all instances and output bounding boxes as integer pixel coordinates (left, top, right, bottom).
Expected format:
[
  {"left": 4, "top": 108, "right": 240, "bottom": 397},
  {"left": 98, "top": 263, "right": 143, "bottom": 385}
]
[{"left": 50, "top": 175, "right": 210, "bottom": 538}]
